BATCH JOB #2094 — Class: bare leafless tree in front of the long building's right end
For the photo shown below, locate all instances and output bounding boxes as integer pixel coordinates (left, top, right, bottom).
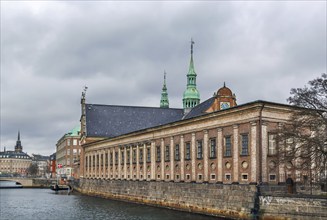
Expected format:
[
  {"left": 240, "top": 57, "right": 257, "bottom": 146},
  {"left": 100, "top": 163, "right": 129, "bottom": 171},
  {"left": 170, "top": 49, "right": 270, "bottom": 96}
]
[{"left": 277, "top": 73, "right": 327, "bottom": 185}]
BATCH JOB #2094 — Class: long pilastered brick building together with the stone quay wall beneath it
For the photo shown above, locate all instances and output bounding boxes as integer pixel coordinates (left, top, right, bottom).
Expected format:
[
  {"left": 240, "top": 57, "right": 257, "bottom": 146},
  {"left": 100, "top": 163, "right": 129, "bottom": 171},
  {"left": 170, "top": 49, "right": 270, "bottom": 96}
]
[{"left": 75, "top": 42, "right": 322, "bottom": 218}]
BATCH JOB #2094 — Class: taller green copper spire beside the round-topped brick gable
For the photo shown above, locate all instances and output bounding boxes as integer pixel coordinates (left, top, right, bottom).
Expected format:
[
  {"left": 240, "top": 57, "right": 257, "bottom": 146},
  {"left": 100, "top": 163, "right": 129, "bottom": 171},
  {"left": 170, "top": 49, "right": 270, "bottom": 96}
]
[{"left": 183, "top": 39, "right": 200, "bottom": 114}]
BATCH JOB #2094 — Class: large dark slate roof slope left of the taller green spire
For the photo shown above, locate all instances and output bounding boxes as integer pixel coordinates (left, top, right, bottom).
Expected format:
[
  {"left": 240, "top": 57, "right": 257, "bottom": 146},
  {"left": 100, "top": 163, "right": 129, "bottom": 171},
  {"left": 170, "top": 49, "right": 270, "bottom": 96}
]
[{"left": 85, "top": 104, "right": 184, "bottom": 137}]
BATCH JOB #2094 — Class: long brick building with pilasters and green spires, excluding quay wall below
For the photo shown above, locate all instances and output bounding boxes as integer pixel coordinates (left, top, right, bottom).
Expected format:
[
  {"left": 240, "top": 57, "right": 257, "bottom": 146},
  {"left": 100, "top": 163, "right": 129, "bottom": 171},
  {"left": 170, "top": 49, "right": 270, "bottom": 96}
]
[{"left": 81, "top": 41, "right": 304, "bottom": 184}]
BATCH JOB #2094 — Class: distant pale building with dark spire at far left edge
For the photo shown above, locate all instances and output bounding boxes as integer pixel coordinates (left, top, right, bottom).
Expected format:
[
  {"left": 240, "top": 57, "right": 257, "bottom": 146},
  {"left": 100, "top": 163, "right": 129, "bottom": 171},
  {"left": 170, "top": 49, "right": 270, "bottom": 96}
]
[{"left": 0, "top": 132, "right": 32, "bottom": 176}]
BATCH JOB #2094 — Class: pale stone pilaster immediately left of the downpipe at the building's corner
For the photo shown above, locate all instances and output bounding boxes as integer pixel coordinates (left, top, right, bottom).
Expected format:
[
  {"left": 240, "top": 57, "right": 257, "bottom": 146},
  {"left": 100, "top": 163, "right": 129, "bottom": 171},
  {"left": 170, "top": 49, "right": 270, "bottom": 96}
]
[{"left": 250, "top": 122, "right": 258, "bottom": 183}]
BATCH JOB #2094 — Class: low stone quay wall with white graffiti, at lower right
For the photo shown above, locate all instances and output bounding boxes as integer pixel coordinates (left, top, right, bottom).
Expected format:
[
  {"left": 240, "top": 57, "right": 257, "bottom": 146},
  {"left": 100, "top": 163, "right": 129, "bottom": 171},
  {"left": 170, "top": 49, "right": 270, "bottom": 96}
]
[{"left": 259, "top": 195, "right": 327, "bottom": 220}]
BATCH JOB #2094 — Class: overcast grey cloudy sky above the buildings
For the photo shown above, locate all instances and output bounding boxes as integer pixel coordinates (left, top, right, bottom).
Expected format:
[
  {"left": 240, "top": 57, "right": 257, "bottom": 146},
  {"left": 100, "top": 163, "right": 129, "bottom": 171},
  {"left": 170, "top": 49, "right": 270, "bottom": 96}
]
[{"left": 0, "top": 1, "right": 327, "bottom": 155}]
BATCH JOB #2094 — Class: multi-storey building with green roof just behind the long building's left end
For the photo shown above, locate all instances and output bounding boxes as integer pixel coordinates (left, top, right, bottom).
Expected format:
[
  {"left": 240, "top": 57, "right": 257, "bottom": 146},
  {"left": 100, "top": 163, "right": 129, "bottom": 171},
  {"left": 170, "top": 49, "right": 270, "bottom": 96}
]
[{"left": 56, "top": 126, "right": 81, "bottom": 178}]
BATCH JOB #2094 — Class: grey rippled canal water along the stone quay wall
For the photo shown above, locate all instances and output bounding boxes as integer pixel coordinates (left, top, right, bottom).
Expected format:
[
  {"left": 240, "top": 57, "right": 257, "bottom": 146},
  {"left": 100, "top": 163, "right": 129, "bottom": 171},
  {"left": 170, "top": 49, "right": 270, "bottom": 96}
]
[{"left": 0, "top": 185, "right": 224, "bottom": 220}]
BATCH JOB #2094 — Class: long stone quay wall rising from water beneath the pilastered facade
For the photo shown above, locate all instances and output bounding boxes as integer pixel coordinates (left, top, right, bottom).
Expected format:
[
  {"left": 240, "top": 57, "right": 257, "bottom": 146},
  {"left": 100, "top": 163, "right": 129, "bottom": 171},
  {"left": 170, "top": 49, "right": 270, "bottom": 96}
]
[{"left": 74, "top": 179, "right": 256, "bottom": 219}]
